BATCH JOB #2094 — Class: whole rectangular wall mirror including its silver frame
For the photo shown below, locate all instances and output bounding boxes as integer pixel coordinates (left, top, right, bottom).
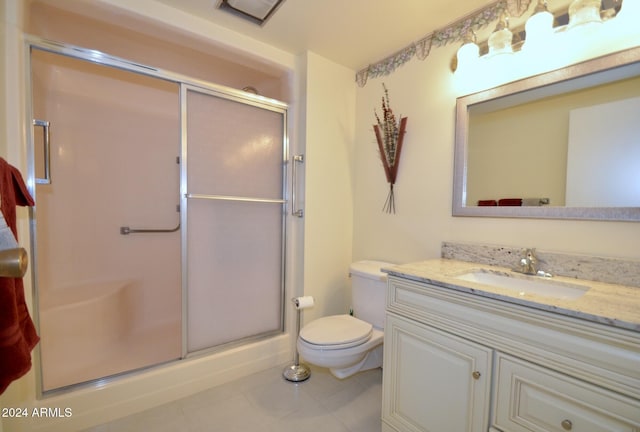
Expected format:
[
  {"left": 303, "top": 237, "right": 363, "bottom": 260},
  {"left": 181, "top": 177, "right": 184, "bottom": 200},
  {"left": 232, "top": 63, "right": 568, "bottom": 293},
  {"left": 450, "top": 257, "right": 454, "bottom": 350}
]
[{"left": 453, "top": 47, "right": 640, "bottom": 221}]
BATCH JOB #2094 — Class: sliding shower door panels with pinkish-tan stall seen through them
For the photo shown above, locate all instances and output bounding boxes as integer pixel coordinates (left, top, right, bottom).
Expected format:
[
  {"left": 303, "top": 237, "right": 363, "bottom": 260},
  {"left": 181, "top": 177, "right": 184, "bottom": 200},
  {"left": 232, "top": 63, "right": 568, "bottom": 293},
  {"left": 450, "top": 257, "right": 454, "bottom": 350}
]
[{"left": 31, "top": 48, "right": 287, "bottom": 392}]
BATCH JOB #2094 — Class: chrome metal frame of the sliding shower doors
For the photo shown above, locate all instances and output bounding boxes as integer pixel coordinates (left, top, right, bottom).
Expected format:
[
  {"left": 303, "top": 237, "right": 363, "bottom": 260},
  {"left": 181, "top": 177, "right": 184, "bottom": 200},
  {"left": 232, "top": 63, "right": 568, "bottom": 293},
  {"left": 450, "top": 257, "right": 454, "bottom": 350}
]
[{"left": 24, "top": 35, "right": 289, "bottom": 398}]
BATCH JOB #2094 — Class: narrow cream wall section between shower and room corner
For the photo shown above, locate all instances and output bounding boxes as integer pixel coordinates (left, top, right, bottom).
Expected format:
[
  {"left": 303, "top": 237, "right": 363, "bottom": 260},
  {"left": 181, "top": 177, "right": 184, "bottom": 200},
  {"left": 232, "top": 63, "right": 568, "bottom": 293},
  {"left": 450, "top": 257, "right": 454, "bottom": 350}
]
[{"left": 303, "top": 52, "right": 355, "bottom": 321}]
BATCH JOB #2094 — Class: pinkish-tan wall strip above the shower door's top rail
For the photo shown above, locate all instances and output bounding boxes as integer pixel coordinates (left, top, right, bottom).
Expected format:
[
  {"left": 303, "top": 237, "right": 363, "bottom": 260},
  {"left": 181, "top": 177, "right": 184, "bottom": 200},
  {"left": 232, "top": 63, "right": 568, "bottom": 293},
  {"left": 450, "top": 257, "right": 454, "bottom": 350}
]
[{"left": 25, "top": 0, "right": 291, "bottom": 102}]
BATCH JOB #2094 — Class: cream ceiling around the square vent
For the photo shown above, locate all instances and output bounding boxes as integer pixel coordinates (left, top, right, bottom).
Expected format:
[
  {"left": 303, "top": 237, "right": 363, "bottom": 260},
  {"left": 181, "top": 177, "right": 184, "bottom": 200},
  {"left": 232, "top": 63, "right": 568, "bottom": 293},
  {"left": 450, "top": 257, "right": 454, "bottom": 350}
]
[{"left": 154, "top": 0, "right": 494, "bottom": 71}]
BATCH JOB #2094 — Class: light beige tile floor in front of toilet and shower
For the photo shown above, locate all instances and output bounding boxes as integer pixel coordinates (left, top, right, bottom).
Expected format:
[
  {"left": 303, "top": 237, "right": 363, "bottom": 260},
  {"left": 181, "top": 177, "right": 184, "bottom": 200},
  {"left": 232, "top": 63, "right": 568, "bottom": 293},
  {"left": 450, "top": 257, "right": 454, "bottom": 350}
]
[{"left": 84, "top": 365, "right": 382, "bottom": 432}]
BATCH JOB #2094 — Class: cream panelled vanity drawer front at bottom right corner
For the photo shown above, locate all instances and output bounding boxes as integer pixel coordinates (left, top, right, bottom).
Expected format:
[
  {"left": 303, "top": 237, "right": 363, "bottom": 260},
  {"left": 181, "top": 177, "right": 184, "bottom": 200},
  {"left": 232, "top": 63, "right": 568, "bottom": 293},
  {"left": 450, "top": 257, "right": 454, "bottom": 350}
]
[{"left": 493, "top": 353, "right": 640, "bottom": 432}]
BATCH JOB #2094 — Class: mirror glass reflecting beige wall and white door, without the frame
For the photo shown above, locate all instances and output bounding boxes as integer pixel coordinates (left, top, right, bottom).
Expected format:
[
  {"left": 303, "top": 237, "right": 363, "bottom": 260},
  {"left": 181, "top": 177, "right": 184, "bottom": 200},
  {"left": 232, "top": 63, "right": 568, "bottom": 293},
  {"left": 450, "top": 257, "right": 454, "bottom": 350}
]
[{"left": 466, "top": 72, "right": 640, "bottom": 207}]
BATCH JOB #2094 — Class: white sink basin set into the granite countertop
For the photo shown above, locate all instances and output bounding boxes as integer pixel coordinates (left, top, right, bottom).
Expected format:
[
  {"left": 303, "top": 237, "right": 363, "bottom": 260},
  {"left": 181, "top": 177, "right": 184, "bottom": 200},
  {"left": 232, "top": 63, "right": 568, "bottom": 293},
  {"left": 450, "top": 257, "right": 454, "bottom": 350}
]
[{"left": 456, "top": 270, "right": 590, "bottom": 300}]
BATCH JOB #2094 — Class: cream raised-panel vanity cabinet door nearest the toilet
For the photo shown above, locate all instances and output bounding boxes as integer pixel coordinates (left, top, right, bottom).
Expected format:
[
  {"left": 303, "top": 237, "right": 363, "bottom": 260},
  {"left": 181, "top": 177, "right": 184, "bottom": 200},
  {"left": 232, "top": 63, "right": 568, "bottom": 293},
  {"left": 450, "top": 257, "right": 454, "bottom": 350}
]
[{"left": 382, "top": 314, "right": 492, "bottom": 432}]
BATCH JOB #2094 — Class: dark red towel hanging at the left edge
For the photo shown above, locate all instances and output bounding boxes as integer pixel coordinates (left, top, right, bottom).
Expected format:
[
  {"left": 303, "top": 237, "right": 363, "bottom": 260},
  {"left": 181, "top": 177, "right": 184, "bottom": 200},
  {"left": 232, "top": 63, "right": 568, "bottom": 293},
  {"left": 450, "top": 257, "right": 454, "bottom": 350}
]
[{"left": 0, "top": 158, "right": 40, "bottom": 394}]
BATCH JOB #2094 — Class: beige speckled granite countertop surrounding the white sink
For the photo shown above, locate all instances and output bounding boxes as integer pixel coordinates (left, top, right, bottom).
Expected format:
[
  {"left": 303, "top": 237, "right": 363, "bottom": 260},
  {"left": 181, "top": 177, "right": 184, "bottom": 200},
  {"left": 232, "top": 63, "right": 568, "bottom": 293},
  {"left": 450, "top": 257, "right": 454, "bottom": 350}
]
[{"left": 383, "top": 259, "right": 640, "bottom": 332}]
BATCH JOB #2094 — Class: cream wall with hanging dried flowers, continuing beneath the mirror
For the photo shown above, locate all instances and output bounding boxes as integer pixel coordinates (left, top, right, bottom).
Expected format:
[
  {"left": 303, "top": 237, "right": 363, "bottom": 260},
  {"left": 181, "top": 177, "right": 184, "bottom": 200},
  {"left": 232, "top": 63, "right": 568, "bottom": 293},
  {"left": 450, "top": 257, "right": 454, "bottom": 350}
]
[{"left": 353, "top": 44, "right": 640, "bottom": 262}]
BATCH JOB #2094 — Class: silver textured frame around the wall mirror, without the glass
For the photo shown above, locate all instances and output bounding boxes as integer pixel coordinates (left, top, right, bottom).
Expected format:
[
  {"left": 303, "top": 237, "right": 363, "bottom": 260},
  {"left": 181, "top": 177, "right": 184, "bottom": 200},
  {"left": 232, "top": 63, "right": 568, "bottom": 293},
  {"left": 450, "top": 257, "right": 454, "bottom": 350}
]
[{"left": 452, "top": 47, "right": 640, "bottom": 221}]
